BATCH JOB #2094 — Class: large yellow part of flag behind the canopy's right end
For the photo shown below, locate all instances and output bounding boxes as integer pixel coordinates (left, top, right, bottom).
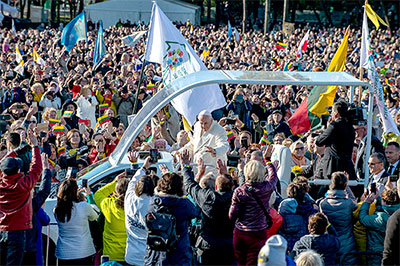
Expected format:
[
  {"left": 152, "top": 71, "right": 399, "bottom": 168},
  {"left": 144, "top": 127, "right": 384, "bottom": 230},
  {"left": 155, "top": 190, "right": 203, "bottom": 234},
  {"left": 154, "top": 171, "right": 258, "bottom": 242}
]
[{"left": 309, "top": 29, "right": 349, "bottom": 116}]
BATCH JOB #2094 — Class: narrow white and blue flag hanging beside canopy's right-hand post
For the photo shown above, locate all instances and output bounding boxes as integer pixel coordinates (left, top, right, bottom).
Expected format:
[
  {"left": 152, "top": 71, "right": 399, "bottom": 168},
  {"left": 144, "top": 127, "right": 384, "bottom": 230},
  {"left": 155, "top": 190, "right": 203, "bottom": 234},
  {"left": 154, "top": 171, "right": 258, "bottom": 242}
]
[{"left": 360, "top": 9, "right": 400, "bottom": 136}]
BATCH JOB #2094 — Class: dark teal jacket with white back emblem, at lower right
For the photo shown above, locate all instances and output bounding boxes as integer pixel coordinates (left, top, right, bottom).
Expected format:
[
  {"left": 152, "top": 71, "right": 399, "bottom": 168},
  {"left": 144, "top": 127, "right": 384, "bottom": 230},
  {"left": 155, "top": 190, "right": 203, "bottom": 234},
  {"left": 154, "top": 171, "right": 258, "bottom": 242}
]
[{"left": 359, "top": 202, "right": 400, "bottom": 265}]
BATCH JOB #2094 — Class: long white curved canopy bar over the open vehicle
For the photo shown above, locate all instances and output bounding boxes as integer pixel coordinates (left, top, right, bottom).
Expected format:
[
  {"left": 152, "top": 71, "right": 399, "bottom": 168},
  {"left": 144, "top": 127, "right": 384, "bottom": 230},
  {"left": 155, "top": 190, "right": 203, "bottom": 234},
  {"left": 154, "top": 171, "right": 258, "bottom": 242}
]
[{"left": 109, "top": 70, "right": 372, "bottom": 166}]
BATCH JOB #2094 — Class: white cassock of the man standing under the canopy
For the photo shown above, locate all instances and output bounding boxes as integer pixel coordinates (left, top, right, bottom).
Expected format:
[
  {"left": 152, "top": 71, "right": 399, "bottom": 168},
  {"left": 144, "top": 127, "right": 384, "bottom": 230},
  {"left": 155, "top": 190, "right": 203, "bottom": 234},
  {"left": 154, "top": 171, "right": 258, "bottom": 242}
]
[{"left": 179, "top": 120, "right": 229, "bottom": 173}]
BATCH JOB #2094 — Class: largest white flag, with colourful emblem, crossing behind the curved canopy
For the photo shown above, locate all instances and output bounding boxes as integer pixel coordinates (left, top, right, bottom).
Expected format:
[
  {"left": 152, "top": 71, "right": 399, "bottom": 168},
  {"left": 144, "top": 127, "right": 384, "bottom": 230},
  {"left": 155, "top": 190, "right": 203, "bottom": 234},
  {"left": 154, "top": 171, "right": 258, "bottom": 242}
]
[{"left": 145, "top": 3, "right": 226, "bottom": 125}]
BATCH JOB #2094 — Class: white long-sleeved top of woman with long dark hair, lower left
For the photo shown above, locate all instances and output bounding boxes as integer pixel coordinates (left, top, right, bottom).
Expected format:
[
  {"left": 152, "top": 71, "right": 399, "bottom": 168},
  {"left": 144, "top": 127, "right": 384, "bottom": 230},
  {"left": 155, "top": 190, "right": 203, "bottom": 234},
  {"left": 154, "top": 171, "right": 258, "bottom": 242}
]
[{"left": 56, "top": 201, "right": 98, "bottom": 260}]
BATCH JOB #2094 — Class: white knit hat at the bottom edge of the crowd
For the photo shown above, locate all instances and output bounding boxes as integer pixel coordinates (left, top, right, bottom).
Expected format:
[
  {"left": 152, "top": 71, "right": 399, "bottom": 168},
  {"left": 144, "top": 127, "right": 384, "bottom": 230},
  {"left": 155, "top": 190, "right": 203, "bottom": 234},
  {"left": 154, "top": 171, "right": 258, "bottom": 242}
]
[{"left": 257, "top": 235, "right": 287, "bottom": 266}]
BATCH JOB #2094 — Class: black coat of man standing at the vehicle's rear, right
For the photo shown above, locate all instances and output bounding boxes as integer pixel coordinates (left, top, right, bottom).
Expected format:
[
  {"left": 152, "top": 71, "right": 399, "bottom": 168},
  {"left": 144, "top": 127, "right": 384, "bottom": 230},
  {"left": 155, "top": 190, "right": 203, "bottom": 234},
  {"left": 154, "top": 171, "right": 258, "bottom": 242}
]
[{"left": 315, "top": 119, "right": 356, "bottom": 180}]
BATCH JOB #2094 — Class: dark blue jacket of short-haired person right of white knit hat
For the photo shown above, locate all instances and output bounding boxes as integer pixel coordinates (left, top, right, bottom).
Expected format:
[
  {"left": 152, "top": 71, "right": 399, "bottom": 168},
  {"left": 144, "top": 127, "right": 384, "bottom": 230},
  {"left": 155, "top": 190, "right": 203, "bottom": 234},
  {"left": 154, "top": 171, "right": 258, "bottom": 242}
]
[{"left": 291, "top": 226, "right": 340, "bottom": 265}]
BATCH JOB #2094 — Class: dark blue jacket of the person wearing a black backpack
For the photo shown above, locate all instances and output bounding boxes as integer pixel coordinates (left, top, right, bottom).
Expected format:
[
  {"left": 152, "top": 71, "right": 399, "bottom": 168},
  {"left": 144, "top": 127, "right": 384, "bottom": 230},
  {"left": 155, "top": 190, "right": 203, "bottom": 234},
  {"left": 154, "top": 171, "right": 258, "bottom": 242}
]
[{"left": 145, "top": 195, "right": 200, "bottom": 266}]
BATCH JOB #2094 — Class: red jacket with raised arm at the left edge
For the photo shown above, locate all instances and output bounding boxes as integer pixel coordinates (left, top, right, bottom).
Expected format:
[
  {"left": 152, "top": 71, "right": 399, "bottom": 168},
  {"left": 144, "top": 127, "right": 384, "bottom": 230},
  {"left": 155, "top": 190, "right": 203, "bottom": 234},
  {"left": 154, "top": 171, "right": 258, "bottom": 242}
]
[{"left": 0, "top": 146, "right": 42, "bottom": 231}]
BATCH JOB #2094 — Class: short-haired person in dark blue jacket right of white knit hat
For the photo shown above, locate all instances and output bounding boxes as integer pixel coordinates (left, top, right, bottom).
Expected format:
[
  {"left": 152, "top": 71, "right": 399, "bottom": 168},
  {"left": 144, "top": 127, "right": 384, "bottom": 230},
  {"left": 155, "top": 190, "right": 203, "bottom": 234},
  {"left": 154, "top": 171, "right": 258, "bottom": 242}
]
[{"left": 291, "top": 212, "right": 340, "bottom": 265}]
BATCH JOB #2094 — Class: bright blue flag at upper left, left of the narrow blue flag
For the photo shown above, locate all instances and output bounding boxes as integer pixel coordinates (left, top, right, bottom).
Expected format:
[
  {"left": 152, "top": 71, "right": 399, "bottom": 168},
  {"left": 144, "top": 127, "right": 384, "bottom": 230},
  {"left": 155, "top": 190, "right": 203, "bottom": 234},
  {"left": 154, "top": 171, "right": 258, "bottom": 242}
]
[{"left": 61, "top": 11, "right": 87, "bottom": 52}]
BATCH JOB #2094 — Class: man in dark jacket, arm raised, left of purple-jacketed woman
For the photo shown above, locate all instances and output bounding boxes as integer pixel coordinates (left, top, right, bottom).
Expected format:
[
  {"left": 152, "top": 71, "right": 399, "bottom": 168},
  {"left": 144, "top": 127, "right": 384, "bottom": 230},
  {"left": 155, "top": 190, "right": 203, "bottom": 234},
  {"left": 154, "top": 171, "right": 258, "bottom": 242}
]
[{"left": 182, "top": 164, "right": 234, "bottom": 265}]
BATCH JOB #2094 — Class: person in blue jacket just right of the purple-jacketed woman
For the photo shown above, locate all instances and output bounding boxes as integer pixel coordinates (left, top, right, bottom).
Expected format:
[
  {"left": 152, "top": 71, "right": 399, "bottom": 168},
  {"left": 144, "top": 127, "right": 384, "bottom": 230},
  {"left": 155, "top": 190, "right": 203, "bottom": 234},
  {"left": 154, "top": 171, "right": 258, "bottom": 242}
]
[{"left": 278, "top": 184, "right": 316, "bottom": 251}]
